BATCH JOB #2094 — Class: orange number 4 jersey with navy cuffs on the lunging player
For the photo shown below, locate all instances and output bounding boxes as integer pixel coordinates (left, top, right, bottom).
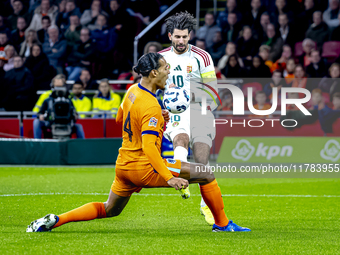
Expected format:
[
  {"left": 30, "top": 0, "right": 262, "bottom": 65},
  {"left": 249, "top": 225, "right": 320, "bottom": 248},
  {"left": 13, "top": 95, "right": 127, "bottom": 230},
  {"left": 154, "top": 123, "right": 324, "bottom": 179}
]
[{"left": 116, "top": 84, "right": 164, "bottom": 170}]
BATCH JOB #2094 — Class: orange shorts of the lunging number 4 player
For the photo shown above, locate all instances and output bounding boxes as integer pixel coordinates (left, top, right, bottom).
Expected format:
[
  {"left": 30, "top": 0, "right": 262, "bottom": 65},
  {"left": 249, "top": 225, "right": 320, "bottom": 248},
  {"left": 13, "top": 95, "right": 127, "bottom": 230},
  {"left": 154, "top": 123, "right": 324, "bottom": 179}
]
[{"left": 111, "top": 159, "right": 181, "bottom": 197}]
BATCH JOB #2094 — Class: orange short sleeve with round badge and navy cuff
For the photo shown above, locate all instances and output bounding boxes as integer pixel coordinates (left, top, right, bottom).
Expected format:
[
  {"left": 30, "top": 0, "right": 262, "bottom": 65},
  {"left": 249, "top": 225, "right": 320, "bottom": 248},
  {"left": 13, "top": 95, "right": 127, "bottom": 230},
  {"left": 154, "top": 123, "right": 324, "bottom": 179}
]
[{"left": 141, "top": 106, "right": 163, "bottom": 137}]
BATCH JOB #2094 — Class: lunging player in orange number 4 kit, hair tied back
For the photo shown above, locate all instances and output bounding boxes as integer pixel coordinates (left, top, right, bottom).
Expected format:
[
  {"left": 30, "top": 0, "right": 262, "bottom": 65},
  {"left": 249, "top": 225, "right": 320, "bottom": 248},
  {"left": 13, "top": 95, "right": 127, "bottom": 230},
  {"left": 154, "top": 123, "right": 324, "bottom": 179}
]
[{"left": 26, "top": 53, "right": 250, "bottom": 232}]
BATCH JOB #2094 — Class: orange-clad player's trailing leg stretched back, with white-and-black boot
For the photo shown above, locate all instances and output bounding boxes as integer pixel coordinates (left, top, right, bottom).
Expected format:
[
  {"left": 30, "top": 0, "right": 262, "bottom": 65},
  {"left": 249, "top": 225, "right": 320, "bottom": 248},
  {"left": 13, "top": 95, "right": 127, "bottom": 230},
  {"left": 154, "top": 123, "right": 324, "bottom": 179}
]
[{"left": 26, "top": 190, "right": 130, "bottom": 232}]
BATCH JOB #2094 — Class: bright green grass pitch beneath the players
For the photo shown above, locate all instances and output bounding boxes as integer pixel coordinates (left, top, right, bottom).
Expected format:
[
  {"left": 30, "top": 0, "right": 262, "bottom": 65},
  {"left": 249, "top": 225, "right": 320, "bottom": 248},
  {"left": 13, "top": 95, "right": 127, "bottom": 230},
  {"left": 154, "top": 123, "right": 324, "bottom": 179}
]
[{"left": 0, "top": 167, "right": 340, "bottom": 254}]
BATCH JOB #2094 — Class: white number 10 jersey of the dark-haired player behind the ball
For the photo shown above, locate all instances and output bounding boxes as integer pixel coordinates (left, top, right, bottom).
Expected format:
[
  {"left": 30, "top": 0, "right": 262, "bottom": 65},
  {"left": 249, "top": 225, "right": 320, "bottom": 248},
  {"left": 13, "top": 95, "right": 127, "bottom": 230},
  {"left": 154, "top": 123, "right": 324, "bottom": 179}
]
[{"left": 159, "top": 44, "right": 216, "bottom": 91}]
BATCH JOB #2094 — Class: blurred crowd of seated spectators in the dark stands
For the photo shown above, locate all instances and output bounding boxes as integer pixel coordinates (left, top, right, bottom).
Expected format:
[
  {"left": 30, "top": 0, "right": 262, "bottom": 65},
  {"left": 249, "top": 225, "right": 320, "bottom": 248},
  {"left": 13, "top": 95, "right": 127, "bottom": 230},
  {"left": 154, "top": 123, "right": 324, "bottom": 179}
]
[{"left": 0, "top": 0, "right": 340, "bottom": 130}]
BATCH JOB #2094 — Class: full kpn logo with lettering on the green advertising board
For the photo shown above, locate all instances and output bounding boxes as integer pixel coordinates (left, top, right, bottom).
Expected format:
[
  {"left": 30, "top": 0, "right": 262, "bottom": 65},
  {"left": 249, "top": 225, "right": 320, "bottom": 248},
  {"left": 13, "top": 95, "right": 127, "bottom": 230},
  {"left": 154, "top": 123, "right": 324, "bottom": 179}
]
[{"left": 231, "top": 139, "right": 293, "bottom": 161}]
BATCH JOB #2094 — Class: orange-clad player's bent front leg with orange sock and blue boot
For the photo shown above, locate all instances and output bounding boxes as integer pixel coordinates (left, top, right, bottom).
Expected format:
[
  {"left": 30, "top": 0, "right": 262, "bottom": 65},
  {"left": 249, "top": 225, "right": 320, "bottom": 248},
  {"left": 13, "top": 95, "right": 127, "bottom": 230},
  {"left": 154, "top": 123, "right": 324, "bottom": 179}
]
[{"left": 179, "top": 162, "right": 250, "bottom": 232}]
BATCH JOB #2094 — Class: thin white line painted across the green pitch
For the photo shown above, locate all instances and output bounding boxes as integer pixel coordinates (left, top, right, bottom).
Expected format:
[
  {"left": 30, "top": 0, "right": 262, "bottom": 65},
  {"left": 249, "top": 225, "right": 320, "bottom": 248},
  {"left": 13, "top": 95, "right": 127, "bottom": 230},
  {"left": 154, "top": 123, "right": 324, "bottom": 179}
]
[{"left": 0, "top": 192, "right": 340, "bottom": 198}]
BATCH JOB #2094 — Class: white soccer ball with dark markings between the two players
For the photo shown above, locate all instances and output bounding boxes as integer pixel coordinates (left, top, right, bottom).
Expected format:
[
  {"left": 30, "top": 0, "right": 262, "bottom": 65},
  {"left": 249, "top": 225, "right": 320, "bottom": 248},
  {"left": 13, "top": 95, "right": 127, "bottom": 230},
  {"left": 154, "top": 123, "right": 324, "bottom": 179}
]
[{"left": 163, "top": 87, "right": 190, "bottom": 113}]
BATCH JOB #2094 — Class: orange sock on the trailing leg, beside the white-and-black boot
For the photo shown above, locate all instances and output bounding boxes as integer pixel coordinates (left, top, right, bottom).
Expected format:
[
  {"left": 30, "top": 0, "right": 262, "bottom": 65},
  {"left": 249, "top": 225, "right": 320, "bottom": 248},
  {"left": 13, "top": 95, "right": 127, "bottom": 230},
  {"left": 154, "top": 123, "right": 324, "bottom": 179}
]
[{"left": 53, "top": 202, "right": 106, "bottom": 228}]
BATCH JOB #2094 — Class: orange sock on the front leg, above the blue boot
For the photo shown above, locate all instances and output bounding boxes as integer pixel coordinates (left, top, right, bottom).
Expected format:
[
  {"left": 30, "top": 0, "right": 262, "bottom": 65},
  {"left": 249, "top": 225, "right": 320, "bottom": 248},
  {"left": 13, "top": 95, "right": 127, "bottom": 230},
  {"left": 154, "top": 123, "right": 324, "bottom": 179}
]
[{"left": 200, "top": 180, "right": 229, "bottom": 227}]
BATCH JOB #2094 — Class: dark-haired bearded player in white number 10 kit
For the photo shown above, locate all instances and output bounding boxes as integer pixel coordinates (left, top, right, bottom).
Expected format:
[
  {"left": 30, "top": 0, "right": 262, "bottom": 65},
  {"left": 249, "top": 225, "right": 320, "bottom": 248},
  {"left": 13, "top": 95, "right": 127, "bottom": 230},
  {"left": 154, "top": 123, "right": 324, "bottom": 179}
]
[{"left": 159, "top": 12, "right": 216, "bottom": 225}]
